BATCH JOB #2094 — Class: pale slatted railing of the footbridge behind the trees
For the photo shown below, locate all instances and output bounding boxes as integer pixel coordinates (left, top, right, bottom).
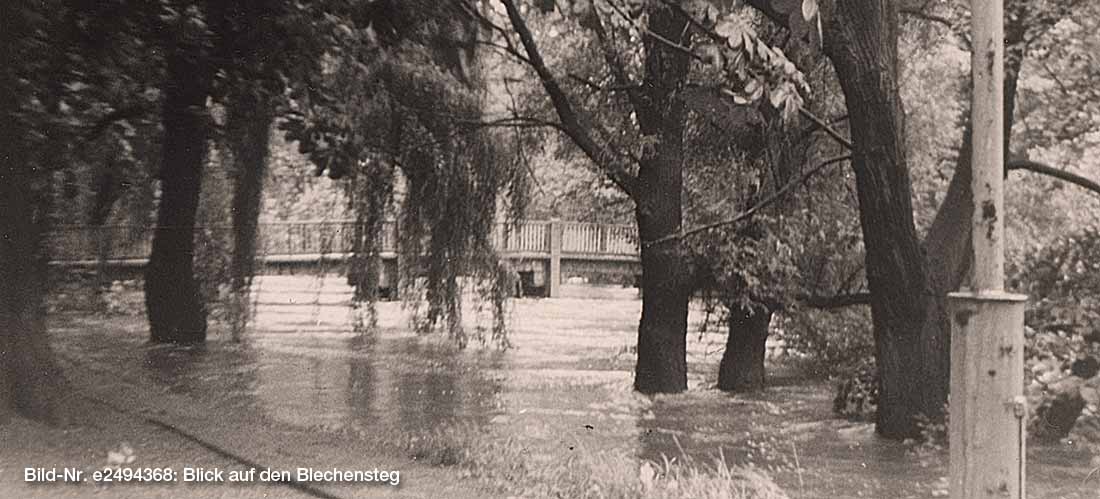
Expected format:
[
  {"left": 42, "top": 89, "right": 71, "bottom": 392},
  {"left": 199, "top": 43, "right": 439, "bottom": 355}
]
[{"left": 48, "top": 220, "right": 638, "bottom": 262}]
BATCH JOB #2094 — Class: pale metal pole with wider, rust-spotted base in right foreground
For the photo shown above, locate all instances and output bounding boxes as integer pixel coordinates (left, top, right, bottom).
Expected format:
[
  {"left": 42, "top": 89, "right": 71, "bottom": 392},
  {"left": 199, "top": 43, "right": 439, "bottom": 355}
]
[{"left": 948, "top": 0, "right": 1027, "bottom": 499}]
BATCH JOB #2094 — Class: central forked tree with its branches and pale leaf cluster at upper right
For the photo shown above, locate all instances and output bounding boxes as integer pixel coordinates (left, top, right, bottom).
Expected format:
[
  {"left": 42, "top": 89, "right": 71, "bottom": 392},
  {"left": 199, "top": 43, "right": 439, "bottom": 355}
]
[{"left": 499, "top": 0, "right": 804, "bottom": 392}]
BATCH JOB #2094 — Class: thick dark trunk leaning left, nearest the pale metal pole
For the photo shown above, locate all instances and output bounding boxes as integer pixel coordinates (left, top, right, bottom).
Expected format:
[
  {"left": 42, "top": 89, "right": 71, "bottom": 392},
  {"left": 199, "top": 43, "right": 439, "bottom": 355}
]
[{"left": 825, "top": 0, "right": 948, "bottom": 439}]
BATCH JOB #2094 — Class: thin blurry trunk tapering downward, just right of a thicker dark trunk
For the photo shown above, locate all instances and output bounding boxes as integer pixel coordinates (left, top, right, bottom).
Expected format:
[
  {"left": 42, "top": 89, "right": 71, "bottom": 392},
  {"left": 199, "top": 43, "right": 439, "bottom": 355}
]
[{"left": 227, "top": 92, "right": 274, "bottom": 340}]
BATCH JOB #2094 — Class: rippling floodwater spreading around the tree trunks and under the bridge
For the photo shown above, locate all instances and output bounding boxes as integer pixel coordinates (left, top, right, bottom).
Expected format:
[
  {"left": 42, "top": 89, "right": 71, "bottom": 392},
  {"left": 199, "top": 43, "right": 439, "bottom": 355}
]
[{"left": 52, "top": 276, "right": 1100, "bottom": 499}]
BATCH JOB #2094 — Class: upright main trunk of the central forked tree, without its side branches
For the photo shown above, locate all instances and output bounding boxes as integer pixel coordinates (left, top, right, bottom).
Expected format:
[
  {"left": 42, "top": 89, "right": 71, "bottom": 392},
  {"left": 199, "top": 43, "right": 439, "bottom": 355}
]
[{"left": 634, "top": 5, "right": 690, "bottom": 393}]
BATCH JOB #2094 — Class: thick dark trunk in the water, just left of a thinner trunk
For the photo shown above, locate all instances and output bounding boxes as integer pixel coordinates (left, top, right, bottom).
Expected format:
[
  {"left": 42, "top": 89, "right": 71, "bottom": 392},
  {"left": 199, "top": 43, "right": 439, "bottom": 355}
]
[{"left": 145, "top": 48, "right": 210, "bottom": 343}]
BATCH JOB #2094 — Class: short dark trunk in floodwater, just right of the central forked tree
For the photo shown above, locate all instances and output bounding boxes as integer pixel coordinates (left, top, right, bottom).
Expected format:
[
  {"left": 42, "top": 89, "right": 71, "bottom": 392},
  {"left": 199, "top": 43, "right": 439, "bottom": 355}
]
[{"left": 718, "top": 307, "right": 772, "bottom": 391}]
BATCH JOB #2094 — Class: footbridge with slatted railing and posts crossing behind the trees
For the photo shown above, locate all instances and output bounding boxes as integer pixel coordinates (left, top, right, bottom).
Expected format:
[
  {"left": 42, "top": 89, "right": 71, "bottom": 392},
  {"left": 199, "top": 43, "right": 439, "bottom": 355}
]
[{"left": 50, "top": 220, "right": 641, "bottom": 297}]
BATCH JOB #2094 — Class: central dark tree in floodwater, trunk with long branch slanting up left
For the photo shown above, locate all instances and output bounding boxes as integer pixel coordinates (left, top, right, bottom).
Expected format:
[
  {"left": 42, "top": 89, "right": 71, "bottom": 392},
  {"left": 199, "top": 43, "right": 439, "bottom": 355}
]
[{"left": 504, "top": 1, "right": 692, "bottom": 392}]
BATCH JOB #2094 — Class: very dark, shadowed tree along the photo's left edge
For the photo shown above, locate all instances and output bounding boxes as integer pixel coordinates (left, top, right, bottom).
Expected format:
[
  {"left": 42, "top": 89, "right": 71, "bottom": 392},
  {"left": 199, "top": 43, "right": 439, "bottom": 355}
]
[{"left": 0, "top": 1, "right": 74, "bottom": 422}]
